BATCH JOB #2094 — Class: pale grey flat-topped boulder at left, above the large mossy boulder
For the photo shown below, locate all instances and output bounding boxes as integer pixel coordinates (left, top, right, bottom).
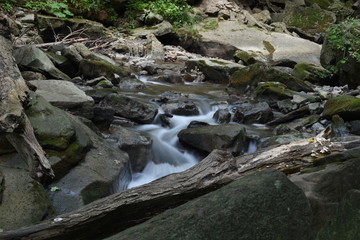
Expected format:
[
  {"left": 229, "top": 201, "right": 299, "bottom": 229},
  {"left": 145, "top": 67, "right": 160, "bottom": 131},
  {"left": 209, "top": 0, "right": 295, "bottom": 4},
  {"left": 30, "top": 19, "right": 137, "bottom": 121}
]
[{"left": 31, "top": 80, "right": 94, "bottom": 119}]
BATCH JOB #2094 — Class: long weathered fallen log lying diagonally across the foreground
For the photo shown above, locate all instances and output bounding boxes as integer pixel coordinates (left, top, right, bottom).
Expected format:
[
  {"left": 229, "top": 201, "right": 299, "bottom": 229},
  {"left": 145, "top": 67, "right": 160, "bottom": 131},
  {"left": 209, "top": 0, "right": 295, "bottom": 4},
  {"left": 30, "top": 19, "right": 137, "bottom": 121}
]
[{"left": 0, "top": 129, "right": 360, "bottom": 240}]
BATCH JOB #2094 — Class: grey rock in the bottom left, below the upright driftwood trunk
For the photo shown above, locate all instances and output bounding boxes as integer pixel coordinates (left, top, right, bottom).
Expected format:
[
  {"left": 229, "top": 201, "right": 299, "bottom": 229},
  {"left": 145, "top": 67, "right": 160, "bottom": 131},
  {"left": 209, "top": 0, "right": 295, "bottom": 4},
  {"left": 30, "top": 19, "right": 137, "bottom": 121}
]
[{"left": 0, "top": 158, "right": 52, "bottom": 231}]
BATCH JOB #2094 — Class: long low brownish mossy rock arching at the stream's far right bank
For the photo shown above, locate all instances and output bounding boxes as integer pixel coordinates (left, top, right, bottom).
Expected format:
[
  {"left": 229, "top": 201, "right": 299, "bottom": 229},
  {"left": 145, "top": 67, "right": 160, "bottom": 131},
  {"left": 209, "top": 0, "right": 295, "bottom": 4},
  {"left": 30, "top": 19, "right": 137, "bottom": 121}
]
[{"left": 228, "top": 63, "right": 313, "bottom": 92}]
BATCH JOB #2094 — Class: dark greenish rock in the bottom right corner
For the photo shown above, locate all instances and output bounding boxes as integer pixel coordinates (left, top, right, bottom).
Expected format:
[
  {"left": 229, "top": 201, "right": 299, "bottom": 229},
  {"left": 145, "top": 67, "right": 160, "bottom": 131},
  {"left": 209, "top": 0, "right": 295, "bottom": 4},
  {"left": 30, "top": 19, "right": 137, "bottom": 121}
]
[{"left": 316, "top": 189, "right": 360, "bottom": 240}]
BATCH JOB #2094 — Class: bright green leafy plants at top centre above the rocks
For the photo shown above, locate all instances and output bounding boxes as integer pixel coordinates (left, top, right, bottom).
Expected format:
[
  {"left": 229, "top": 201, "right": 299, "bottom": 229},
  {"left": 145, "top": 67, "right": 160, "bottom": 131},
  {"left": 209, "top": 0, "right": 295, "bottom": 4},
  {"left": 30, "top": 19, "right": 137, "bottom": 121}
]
[{"left": 127, "top": 0, "right": 192, "bottom": 27}]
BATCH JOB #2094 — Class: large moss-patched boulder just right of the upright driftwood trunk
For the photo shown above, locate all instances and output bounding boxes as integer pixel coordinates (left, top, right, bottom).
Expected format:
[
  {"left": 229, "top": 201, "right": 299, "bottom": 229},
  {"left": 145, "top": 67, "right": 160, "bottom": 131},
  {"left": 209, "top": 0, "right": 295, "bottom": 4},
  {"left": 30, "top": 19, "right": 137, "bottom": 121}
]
[{"left": 26, "top": 94, "right": 92, "bottom": 179}]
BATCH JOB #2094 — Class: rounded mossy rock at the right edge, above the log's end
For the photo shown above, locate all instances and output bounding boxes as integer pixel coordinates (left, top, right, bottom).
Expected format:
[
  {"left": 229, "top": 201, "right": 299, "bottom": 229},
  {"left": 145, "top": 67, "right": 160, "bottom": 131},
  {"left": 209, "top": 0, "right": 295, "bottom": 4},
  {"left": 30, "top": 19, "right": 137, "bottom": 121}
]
[{"left": 322, "top": 95, "right": 360, "bottom": 120}]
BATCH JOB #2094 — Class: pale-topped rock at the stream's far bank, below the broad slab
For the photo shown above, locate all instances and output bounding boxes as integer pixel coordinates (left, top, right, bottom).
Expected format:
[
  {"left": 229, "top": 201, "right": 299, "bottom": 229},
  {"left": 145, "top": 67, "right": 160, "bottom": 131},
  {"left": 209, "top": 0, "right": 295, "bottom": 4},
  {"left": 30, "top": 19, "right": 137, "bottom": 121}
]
[{"left": 185, "top": 58, "right": 243, "bottom": 83}]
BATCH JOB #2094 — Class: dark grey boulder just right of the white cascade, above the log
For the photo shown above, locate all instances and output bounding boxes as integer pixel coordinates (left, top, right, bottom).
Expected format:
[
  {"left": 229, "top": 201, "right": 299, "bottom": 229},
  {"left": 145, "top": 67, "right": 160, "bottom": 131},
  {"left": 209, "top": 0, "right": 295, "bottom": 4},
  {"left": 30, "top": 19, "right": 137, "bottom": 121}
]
[{"left": 178, "top": 124, "right": 247, "bottom": 154}]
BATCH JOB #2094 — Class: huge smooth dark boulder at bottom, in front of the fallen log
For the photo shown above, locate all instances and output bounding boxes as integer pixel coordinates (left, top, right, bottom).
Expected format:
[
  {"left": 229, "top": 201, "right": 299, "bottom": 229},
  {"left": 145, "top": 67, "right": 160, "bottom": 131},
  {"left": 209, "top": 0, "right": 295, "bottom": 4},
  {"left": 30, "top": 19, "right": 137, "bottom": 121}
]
[{"left": 107, "top": 170, "right": 311, "bottom": 240}]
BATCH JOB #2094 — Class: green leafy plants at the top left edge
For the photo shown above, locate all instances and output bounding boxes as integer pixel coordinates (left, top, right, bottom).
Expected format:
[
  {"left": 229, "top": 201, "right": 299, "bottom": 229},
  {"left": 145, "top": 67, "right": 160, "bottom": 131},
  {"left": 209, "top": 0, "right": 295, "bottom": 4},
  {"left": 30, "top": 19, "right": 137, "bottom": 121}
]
[{"left": 23, "top": 0, "right": 74, "bottom": 18}]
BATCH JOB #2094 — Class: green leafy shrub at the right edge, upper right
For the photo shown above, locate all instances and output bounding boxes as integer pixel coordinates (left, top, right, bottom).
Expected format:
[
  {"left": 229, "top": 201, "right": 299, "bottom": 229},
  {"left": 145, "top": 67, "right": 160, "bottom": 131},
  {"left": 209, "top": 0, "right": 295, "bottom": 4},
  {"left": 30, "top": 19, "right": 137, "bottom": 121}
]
[{"left": 327, "top": 18, "right": 360, "bottom": 64}]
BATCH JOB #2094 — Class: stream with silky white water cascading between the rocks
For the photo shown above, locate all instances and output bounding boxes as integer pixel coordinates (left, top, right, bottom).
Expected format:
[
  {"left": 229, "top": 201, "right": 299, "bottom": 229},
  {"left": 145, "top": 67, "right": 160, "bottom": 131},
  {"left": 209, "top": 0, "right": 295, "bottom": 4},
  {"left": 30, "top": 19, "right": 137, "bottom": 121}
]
[{"left": 109, "top": 76, "right": 268, "bottom": 191}]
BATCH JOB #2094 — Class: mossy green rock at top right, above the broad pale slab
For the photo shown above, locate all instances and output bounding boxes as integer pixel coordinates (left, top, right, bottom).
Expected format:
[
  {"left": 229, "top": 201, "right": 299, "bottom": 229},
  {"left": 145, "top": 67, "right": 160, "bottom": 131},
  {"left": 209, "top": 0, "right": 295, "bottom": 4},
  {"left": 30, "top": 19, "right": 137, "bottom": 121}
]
[{"left": 283, "top": 2, "right": 336, "bottom": 33}]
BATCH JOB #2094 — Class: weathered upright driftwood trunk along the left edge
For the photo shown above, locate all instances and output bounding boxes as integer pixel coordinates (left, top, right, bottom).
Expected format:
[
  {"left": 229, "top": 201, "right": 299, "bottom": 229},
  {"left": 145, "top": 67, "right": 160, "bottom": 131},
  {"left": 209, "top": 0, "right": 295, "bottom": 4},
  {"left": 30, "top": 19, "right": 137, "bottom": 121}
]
[{"left": 0, "top": 13, "right": 54, "bottom": 180}]
